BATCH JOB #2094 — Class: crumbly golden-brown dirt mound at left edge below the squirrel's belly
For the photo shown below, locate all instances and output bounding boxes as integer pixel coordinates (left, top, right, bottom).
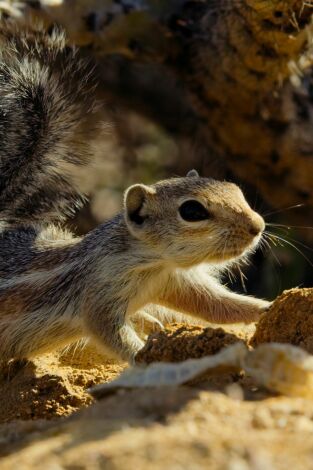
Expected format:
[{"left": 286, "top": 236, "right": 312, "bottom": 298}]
[{"left": 0, "top": 347, "right": 123, "bottom": 423}]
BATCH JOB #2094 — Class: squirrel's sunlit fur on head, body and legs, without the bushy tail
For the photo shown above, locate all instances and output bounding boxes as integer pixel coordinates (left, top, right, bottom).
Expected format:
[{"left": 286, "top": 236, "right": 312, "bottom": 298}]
[{"left": 0, "top": 176, "right": 269, "bottom": 360}]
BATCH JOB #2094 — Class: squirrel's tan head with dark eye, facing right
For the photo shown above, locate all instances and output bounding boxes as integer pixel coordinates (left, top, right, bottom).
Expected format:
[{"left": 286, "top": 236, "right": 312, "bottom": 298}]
[{"left": 124, "top": 170, "right": 265, "bottom": 267}]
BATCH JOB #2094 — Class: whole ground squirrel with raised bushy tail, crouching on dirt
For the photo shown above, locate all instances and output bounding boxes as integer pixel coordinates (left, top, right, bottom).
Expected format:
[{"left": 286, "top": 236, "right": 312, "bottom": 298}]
[{"left": 0, "top": 24, "right": 269, "bottom": 360}]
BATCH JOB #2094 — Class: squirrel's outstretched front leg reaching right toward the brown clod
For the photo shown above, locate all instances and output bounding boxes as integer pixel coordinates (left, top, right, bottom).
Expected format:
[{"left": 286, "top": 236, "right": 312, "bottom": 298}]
[{"left": 156, "top": 276, "right": 271, "bottom": 323}]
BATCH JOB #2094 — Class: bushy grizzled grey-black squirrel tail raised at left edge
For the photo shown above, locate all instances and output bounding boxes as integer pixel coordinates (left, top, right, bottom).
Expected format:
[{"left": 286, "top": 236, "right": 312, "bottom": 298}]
[{"left": 0, "top": 26, "right": 97, "bottom": 224}]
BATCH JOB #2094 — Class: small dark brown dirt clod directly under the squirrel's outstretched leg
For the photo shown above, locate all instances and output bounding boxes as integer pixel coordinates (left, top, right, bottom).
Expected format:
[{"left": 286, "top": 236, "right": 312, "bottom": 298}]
[{"left": 136, "top": 323, "right": 242, "bottom": 364}]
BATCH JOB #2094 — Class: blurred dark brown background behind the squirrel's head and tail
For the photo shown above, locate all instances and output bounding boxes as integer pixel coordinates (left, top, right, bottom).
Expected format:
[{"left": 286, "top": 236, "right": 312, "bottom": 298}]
[{"left": 0, "top": 0, "right": 313, "bottom": 299}]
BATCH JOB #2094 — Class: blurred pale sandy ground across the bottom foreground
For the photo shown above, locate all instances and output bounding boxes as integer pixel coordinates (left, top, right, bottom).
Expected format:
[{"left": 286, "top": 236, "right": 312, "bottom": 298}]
[{"left": 0, "top": 387, "right": 313, "bottom": 470}]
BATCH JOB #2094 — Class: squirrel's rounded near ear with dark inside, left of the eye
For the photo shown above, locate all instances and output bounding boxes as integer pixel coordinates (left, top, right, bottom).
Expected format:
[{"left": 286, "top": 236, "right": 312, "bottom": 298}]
[{"left": 124, "top": 184, "right": 155, "bottom": 225}]
